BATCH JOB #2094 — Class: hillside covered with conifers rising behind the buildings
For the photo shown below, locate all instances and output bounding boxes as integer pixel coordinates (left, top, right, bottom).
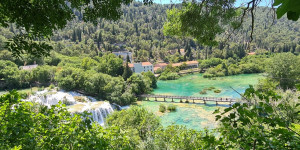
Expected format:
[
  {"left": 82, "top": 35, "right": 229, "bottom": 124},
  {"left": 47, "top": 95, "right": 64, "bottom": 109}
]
[{"left": 0, "top": 2, "right": 300, "bottom": 62}]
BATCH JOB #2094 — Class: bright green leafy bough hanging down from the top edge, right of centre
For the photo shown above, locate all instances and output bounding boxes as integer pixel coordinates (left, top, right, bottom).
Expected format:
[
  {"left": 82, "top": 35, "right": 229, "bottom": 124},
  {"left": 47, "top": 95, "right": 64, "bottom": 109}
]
[{"left": 164, "top": 0, "right": 236, "bottom": 46}]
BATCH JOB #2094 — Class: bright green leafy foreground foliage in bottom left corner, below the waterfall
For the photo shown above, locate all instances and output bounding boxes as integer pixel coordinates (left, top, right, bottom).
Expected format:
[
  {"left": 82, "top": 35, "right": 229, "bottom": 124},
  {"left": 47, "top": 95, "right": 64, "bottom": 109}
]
[{"left": 0, "top": 91, "right": 135, "bottom": 149}]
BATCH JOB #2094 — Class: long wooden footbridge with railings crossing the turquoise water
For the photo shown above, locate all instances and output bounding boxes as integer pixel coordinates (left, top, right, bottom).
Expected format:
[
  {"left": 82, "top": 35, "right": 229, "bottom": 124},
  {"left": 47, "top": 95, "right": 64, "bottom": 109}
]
[{"left": 139, "top": 94, "right": 236, "bottom": 105}]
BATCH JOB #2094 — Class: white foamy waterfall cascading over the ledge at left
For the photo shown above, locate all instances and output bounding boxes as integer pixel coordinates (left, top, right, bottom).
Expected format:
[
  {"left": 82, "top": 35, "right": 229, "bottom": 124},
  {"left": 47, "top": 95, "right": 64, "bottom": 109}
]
[{"left": 25, "top": 90, "right": 114, "bottom": 126}]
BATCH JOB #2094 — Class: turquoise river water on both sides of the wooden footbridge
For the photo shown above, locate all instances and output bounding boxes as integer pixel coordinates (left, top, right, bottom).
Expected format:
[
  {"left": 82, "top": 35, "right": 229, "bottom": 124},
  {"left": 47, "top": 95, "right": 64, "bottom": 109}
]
[{"left": 139, "top": 74, "right": 263, "bottom": 130}]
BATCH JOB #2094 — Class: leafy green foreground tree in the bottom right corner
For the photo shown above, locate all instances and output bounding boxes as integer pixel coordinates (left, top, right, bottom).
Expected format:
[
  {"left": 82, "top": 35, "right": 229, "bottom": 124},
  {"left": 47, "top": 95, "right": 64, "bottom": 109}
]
[{"left": 215, "top": 87, "right": 300, "bottom": 149}]
